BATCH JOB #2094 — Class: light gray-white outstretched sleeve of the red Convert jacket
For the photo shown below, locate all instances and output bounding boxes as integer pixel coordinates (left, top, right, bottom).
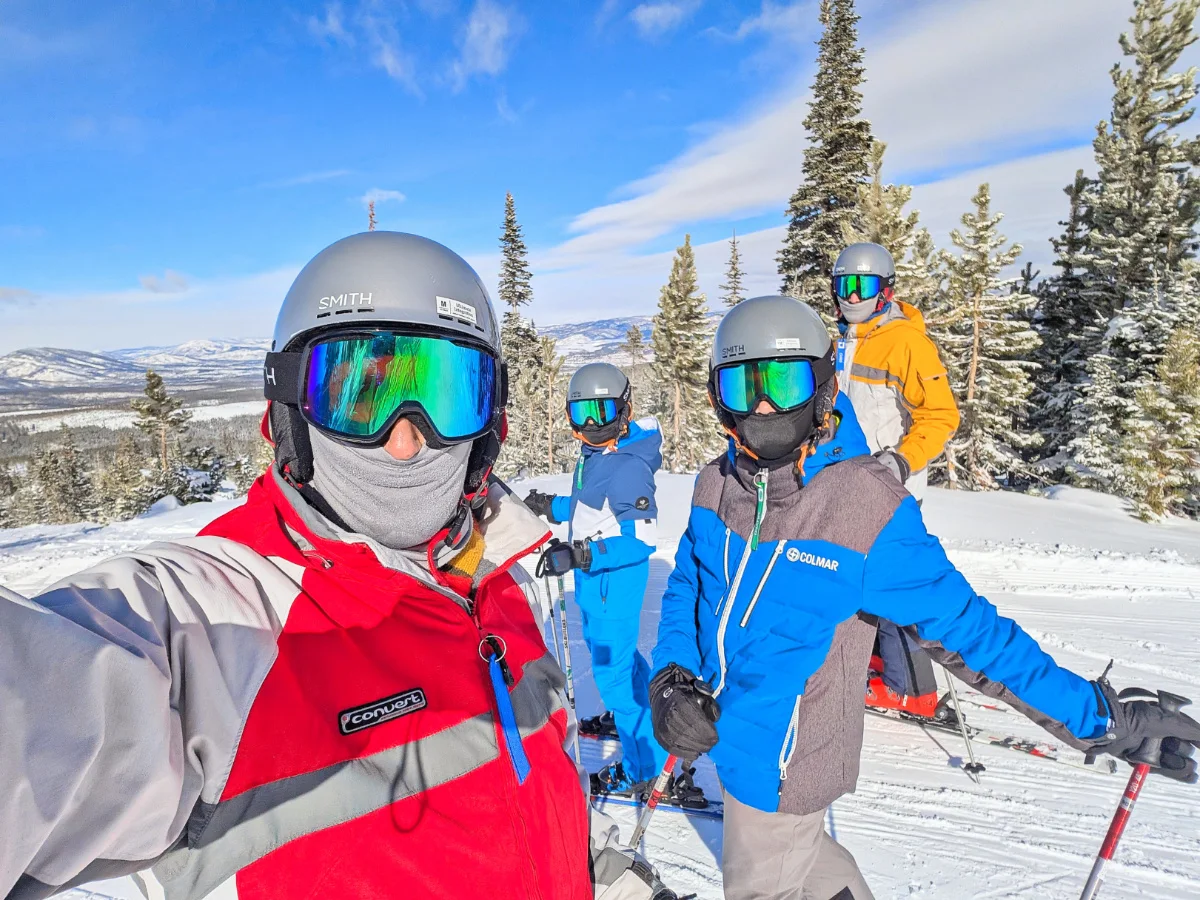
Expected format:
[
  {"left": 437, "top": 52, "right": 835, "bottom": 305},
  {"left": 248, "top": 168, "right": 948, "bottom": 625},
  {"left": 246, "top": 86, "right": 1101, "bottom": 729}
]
[{"left": 0, "top": 538, "right": 299, "bottom": 896}]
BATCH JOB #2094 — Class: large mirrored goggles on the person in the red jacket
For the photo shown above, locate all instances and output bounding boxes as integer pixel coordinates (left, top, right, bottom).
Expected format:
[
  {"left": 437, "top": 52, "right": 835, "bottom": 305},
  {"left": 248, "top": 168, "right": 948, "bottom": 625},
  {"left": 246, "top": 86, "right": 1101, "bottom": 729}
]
[{"left": 300, "top": 331, "right": 499, "bottom": 443}]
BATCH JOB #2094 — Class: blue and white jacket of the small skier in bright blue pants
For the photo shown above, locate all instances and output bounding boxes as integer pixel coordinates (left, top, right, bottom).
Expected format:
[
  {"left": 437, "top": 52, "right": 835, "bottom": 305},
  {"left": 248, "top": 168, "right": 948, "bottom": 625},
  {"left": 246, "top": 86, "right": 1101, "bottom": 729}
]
[{"left": 550, "top": 418, "right": 662, "bottom": 612}]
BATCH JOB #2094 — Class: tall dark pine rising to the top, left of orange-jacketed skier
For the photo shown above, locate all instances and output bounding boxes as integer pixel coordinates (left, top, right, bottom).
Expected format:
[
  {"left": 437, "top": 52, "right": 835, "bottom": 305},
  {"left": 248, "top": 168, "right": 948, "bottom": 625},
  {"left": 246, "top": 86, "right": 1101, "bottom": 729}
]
[{"left": 776, "top": 0, "right": 871, "bottom": 308}]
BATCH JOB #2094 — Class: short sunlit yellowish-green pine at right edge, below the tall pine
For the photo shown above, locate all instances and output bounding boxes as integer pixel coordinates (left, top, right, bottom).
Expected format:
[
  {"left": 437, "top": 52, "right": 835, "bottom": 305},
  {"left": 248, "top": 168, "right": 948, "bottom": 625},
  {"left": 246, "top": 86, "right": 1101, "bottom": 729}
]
[{"left": 1120, "top": 328, "right": 1200, "bottom": 521}]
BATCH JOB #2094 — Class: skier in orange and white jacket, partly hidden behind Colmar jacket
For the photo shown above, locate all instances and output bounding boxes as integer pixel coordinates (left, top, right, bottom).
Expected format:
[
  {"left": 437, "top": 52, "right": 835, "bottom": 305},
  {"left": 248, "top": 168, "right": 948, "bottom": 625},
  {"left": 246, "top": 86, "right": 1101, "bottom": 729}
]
[{"left": 830, "top": 244, "right": 959, "bottom": 716}]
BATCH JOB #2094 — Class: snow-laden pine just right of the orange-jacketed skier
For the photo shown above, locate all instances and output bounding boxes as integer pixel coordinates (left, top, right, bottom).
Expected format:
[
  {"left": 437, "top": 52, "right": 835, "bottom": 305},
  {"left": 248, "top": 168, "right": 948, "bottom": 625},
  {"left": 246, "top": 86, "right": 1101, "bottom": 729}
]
[{"left": 942, "top": 184, "right": 1039, "bottom": 491}]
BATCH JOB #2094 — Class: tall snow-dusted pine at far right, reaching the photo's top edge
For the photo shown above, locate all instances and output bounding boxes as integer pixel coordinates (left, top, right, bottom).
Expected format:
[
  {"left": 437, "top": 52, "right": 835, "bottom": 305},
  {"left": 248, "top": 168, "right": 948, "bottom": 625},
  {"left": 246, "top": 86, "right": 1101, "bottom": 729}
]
[{"left": 1069, "top": 0, "right": 1200, "bottom": 491}]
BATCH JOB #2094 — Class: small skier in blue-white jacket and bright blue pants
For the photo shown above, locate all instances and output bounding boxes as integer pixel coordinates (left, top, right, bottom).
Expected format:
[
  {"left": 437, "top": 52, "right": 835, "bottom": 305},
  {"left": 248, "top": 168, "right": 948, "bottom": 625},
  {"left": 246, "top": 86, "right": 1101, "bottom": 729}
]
[{"left": 524, "top": 362, "right": 700, "bottom": 803}]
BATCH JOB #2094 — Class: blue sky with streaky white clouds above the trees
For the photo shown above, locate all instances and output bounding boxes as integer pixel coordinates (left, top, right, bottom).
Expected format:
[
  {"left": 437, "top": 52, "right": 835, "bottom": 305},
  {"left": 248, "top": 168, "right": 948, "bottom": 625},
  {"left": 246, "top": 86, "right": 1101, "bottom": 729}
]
[{"left": 0, "top": 0, "right": 1185, "bottom": 352}]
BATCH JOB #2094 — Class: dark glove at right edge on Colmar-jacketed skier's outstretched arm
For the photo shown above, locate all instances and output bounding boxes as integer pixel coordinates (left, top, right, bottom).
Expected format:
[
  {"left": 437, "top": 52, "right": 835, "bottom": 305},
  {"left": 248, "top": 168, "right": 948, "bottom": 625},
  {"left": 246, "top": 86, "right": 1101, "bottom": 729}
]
[{"left": 1088, "top": 676, "right": 1200, "bottom": 785}]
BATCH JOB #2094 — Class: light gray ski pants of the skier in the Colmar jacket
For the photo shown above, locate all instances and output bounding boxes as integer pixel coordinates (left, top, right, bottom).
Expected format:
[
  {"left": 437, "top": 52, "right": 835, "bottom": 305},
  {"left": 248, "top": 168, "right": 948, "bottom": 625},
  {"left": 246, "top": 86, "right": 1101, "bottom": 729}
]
[{"left": 721, "top": 793, "right": 875, "bottom": 900}]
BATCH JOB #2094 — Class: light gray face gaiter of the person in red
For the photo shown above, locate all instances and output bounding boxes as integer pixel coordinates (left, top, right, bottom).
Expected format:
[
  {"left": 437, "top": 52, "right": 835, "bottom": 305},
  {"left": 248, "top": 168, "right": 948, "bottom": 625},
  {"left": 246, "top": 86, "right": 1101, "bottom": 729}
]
[{"left": 308, "top": 428, "right": 472, "bottom": 550}]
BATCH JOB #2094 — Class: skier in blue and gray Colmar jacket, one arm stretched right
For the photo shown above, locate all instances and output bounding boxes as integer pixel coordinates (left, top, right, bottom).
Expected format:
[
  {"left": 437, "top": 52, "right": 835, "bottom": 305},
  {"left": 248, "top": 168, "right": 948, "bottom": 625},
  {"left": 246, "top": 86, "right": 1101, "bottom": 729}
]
[{"left": 650, "top": 296, "right": 1200, "bottom": 900}]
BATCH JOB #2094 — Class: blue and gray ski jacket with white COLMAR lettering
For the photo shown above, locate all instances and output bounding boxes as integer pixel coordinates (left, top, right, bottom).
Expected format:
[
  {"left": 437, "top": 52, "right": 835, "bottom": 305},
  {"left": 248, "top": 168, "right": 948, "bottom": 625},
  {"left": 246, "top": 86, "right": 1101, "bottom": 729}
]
[{"left": 654, "top": 396, "right": 1109, "bottom": 812}]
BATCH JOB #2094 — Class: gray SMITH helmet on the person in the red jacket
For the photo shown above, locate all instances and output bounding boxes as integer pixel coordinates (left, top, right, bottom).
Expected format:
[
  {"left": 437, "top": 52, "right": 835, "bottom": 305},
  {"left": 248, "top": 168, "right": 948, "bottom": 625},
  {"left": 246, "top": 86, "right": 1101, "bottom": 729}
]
[{"left": 271, "top": 232, "right": 500, "bottom": 355}]
